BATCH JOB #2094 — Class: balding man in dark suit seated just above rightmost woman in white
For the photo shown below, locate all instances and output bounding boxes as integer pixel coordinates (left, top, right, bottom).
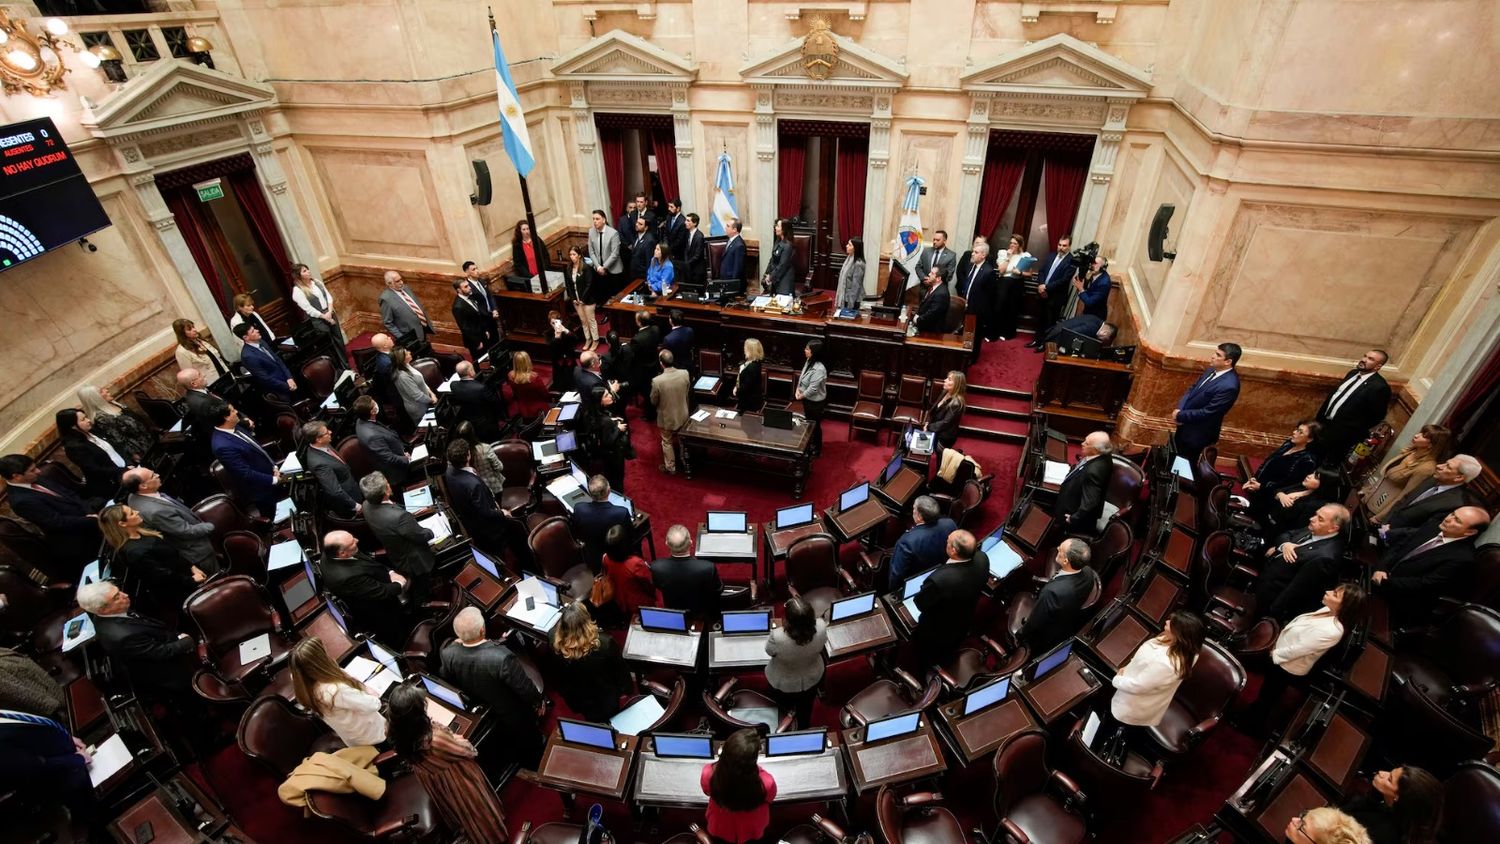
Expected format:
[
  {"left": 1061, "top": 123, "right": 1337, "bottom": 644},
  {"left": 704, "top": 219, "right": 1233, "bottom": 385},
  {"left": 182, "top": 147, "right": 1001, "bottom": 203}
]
[{"left": 1256, "top": 504, "right": 1349, "bottom": 624}]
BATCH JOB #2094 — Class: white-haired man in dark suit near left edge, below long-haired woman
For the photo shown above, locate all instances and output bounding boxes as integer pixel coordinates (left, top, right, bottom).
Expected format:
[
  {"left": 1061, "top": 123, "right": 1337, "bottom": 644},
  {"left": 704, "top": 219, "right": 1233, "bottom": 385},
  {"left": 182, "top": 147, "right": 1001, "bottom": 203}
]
[{"left": 78, "top": 580, "right": 198, "bottom": 700}]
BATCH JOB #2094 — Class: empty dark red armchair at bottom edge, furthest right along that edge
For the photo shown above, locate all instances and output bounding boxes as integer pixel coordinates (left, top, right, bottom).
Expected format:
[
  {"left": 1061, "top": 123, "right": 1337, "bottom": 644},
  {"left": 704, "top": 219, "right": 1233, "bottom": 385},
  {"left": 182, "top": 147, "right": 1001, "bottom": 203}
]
[{"left": 995, "top": 730, "right": 1089, "bottom": 844}]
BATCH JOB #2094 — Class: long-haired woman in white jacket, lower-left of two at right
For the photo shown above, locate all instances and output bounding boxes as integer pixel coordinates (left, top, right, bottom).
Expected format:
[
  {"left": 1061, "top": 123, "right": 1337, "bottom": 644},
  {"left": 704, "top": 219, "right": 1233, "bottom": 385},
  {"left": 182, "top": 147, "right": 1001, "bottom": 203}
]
[{"left": 1110, "top": 610, "right": 1205, "bottom": 727}]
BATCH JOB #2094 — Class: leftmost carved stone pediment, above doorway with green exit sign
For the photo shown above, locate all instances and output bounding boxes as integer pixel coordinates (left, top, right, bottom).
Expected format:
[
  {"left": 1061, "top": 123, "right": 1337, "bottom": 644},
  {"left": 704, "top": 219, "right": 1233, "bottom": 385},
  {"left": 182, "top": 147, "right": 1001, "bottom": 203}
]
[{"left": 83, "top": 60, "right": 276, "bottom": 138}]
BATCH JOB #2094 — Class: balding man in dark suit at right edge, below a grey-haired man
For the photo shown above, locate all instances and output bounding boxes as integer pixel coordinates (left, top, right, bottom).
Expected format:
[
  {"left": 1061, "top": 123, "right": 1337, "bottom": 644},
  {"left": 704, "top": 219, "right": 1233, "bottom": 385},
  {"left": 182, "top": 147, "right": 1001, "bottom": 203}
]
[{"left": 1370, "top": 507, "right": 1490, "bottom": 627}]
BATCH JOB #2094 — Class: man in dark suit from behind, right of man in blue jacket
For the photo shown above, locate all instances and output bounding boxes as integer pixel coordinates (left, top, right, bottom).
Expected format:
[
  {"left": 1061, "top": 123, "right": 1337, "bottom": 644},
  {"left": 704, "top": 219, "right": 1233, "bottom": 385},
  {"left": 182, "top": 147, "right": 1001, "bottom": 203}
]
[{"left": 912, "top": 531, "right": 990, "bottom": 673}]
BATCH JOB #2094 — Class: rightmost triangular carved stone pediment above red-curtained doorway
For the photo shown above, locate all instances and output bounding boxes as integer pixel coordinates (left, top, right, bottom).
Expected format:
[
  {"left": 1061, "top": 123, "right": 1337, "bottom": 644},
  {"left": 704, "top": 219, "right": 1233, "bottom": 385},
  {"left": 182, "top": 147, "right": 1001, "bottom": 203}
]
[{"left": 962, "top": 33, "right": 1151, "bottom": 99}]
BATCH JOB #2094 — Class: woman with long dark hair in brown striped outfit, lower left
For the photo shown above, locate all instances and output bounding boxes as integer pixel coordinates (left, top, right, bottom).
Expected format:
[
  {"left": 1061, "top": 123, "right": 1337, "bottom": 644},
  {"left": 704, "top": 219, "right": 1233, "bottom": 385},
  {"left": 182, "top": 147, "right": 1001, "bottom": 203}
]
[{"left": 387, "top": 684, "right": 510, "bottom": 843}]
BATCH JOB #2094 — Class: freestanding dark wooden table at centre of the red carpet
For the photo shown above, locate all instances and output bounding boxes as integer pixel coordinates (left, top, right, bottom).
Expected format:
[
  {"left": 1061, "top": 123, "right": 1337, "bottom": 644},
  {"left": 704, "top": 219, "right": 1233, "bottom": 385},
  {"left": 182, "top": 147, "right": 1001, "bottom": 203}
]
[{"left": 678, "top": 405, "right": 813, "bottom": 498}]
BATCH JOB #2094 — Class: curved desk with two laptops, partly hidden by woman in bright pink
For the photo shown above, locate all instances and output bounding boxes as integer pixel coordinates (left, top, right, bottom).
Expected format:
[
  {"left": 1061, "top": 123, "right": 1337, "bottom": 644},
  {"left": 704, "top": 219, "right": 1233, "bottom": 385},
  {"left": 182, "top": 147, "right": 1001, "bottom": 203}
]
[{"left": 632, "top": 733, "right": 849, "bottom": 808}]
